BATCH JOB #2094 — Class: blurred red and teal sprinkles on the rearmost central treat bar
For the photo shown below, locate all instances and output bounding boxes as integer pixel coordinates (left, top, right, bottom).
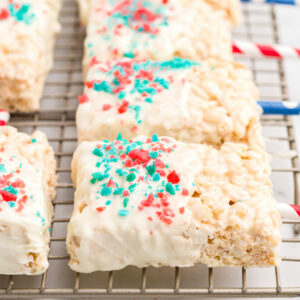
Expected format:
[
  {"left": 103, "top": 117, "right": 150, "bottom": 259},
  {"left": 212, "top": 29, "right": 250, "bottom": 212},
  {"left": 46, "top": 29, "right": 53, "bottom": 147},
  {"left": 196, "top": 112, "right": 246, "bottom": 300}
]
[{"left": 89, "top": 0, "right": 168, "bottom": 58}]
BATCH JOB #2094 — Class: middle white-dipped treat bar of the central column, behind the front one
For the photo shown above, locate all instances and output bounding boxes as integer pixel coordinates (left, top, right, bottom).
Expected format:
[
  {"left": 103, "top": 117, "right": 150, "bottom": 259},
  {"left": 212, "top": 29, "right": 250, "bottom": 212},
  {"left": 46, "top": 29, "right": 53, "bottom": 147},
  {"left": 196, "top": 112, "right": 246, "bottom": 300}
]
[{"left": 77, "top": 58, "right": 263, "bottom": 145}]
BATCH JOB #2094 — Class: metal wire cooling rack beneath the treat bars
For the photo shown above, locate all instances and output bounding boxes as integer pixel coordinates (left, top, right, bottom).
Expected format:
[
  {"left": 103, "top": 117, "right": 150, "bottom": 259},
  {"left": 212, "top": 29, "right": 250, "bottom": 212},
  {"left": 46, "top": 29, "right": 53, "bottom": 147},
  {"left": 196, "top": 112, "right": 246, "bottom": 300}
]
[{"left": 0, "top": 0, "right": 300, "bottom": 299}]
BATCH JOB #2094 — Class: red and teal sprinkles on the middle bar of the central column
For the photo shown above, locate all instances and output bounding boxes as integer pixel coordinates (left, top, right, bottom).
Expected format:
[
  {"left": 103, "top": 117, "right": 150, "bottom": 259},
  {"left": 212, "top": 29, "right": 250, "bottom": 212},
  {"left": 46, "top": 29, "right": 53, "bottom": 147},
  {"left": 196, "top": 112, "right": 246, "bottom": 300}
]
[{"left": 79, "top": 58, "right": 197, "bottom": 130}]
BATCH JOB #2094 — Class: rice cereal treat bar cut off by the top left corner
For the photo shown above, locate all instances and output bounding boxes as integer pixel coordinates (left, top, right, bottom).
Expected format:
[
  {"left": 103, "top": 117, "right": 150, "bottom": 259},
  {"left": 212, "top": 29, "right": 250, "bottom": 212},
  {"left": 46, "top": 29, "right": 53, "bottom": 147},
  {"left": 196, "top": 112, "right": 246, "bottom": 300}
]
[{"left": 0, "top": 0, "right": 62, "bottom": 111}]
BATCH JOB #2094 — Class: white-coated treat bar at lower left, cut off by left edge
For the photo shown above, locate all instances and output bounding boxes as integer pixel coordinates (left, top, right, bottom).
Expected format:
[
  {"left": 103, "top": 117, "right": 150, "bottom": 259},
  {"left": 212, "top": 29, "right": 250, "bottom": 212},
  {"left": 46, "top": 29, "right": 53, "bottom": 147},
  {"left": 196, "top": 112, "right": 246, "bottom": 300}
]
[{"left": 0, "top": 126, "right": 56, "bottom": 275}]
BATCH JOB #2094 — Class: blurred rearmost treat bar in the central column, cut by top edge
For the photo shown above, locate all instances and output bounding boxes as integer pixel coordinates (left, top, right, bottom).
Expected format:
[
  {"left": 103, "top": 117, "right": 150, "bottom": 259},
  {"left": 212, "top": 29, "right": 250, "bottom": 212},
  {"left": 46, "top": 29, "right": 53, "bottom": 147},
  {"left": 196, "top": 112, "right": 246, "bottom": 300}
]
[{"left": 83, "top": 0, "right": 236, "bottom": 74}]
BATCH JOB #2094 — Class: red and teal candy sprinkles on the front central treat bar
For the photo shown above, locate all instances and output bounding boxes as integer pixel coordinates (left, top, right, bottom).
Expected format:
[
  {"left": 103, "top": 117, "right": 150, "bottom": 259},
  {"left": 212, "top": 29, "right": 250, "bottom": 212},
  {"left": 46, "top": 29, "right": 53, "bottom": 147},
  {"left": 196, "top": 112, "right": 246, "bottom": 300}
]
[{"left": 90, "top": 134, "right": 189, "bottom": 225}]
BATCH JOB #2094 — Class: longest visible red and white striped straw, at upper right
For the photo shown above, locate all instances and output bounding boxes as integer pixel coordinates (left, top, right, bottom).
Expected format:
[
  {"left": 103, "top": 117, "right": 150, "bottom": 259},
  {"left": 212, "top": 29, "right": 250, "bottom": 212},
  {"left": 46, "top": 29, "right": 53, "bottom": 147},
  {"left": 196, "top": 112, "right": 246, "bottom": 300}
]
[{"left": 232, "top": 41, "right": 300, "bottom": 59}]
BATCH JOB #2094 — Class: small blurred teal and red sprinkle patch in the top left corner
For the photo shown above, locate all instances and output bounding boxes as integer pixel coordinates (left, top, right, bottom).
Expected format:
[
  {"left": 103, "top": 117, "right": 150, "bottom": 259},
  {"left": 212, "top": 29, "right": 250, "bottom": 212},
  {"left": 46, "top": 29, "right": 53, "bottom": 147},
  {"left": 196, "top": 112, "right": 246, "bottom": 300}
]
[{"left": 0, "top": 0, "right": 35, "bottom": 25}]
